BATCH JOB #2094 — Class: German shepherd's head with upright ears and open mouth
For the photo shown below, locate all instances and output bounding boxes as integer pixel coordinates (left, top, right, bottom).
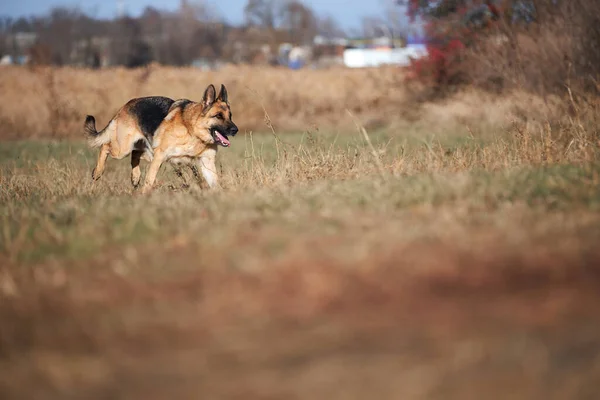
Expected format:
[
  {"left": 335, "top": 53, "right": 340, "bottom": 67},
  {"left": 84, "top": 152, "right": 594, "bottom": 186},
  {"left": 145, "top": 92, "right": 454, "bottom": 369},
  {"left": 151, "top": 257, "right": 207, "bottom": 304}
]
[{"left": 202, "top": 85, "right": 238, "bottom": 147}]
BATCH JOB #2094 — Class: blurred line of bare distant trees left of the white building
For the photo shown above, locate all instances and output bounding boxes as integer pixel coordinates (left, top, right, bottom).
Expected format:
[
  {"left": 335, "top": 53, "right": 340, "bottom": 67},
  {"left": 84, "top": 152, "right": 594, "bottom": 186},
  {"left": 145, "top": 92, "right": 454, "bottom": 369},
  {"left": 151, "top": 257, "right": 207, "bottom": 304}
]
[{"left": 0, "top": 0, "right": 344, "bottom": 67}]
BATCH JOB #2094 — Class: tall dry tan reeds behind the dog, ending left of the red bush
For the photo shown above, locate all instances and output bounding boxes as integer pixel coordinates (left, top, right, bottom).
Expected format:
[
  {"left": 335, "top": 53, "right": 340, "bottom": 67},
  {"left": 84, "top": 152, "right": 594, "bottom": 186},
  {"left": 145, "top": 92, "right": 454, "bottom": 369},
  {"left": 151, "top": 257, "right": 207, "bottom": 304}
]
[{"left": 0, "top": 66, "right": 403, "bottom": 137}]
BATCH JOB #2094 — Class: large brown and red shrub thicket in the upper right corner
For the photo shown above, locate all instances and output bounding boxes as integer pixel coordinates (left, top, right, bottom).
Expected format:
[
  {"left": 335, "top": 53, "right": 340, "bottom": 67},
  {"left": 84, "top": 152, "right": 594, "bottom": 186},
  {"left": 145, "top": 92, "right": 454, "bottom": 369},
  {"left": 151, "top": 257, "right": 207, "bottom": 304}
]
[{"left": 408, "top": 0, "right": 600, "bottom": 95}]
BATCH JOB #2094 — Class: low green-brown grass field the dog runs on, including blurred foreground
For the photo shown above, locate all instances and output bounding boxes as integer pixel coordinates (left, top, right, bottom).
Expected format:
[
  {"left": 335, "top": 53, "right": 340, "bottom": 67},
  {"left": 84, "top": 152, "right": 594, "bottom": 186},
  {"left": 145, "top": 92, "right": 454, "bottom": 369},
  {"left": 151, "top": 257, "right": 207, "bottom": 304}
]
[{"left": 0, "top": 76, "right": 600, "bottom": 399}]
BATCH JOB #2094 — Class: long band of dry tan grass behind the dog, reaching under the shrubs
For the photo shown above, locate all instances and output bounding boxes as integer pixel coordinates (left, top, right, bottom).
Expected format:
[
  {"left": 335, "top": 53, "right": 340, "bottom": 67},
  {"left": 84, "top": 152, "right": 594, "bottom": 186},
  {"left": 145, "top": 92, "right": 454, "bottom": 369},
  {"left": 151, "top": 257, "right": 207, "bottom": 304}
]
[{"left": 0, "top": 66, "right": 566, "bottom": 139}]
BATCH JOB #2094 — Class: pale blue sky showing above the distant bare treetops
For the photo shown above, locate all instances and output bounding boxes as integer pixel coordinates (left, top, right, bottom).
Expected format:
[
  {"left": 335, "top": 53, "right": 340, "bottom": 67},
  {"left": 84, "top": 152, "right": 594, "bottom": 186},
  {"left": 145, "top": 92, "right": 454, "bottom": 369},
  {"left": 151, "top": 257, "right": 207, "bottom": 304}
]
[{"left": 0, "top": 0, "right": 396, "bottom": 29}]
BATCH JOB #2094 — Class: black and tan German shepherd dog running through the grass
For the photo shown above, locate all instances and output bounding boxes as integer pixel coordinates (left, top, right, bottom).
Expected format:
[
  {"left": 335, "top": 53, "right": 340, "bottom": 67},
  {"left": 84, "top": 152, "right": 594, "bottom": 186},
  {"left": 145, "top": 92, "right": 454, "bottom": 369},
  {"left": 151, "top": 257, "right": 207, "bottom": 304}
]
[{"left": 84, "top": 85, "right": 238, "bottom": 193}]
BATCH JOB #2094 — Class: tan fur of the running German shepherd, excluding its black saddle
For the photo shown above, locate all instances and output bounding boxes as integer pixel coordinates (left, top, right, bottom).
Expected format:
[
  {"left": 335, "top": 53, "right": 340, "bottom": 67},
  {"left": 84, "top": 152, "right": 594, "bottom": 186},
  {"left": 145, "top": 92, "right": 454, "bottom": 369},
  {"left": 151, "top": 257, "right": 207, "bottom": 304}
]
[{"left": 86, "top": 85, "right": 237, "bottom": 193}]
